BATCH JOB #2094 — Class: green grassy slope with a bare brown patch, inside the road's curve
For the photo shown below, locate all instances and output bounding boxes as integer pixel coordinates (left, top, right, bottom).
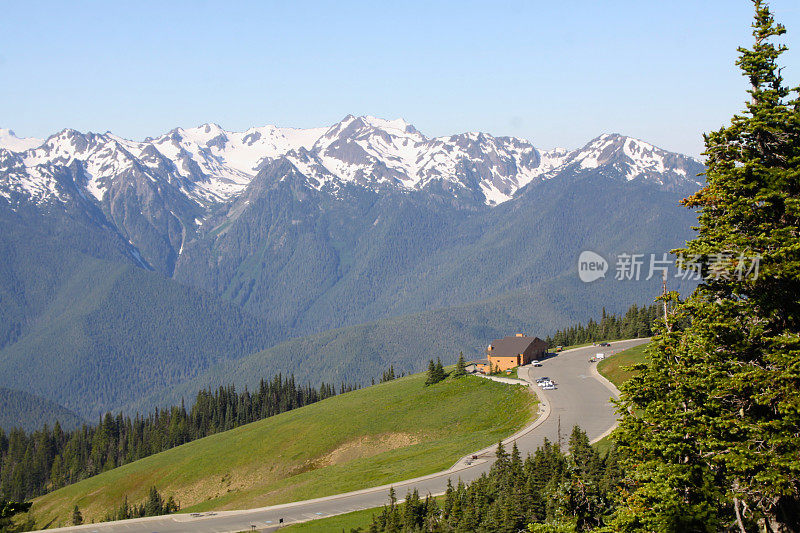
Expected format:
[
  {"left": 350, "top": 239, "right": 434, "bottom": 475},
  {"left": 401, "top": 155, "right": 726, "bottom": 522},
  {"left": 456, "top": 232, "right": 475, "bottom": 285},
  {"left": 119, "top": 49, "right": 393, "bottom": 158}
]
[{"left": 33, "top": 374, "right": 536, "bottom": 525}]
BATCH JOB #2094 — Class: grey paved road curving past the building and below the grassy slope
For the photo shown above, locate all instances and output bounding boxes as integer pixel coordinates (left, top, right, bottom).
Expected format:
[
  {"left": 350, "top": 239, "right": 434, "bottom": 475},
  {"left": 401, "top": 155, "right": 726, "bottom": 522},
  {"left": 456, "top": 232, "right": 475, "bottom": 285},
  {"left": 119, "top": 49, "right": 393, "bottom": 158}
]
[{"left": 40, "top": 339, "right": 647, "bottom": 533}]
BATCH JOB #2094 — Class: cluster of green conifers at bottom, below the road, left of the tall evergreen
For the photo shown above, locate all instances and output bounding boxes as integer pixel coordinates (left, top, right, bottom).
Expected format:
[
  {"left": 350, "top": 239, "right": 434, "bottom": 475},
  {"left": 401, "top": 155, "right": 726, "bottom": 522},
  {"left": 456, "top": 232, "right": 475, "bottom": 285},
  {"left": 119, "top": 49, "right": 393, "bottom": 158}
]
[{"left": 368, "top": 427, "right": 622, "bottom": 533}]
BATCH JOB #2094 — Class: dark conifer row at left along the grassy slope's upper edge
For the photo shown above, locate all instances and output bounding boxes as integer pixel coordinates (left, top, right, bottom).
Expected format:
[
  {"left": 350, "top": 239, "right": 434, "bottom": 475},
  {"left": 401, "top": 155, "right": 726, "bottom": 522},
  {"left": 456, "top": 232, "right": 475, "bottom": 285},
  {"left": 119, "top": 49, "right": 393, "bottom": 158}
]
[{"left": 0, "top": 374, "right": 358, "bottom": 502}]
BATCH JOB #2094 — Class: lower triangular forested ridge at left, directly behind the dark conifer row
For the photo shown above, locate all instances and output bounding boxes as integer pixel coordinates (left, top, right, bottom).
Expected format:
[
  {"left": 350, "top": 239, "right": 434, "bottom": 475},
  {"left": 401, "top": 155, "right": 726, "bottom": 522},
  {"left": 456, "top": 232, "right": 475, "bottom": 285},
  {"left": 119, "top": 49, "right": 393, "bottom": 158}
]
[{"left": 0, "top": 259, "right": 272, "bottom": 418}]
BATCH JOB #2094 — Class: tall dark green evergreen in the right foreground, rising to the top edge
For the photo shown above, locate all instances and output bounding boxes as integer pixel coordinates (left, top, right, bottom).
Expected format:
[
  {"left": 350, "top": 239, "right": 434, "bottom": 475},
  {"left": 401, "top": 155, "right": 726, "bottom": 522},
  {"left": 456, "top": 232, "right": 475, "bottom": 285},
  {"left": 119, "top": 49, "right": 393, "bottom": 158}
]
[{"left": 614, "top": 0, "right": 800, "bottom": 532}]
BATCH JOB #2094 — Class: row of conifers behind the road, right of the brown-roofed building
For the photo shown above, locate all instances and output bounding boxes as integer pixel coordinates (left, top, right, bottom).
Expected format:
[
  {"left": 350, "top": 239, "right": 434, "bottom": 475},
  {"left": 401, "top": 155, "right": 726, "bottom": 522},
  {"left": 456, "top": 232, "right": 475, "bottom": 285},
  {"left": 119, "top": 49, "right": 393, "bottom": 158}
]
[{"left": 545, "top": 304, "right": 663, "bottom": 348}]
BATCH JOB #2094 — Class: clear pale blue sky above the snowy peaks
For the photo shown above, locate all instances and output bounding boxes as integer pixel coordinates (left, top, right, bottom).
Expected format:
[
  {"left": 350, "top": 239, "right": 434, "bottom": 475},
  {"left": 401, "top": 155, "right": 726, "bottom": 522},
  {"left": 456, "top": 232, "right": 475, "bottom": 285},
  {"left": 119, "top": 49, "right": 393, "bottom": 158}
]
[{"left": 0, "top": 0, "right": 800, "bottom": 155}]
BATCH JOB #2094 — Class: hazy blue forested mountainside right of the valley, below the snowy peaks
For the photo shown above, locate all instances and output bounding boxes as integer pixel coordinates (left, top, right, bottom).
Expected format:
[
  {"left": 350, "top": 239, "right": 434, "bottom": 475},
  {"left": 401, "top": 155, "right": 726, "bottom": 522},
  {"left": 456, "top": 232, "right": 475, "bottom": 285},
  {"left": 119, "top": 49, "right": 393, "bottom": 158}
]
[{"left": 175, "top": 166, "right": 693, "bottom": 336}]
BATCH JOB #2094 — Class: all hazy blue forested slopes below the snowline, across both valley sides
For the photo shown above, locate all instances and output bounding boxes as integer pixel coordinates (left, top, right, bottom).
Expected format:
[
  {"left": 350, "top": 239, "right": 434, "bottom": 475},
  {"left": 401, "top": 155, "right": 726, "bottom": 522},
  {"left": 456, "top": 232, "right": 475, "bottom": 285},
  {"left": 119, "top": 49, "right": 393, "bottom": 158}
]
[{"left": 0, "top": 164, "right": 692, "bottom": 418}]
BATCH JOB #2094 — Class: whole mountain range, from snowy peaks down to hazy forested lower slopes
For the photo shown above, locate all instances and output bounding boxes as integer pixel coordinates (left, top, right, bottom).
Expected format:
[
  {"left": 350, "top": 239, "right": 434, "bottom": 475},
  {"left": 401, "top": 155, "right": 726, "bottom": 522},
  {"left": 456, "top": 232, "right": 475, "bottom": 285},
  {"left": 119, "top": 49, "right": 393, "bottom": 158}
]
[{"left": 0, "top": 116, "right": 703, "bottom": 424}]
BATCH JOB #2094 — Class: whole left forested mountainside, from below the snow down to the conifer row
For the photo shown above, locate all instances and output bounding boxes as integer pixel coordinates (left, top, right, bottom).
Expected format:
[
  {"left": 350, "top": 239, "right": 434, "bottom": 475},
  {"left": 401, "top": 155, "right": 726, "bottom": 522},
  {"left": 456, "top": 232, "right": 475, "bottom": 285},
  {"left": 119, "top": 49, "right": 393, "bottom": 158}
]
[{"left": 0, "top": 204, "right": 276, "bottom": 419}]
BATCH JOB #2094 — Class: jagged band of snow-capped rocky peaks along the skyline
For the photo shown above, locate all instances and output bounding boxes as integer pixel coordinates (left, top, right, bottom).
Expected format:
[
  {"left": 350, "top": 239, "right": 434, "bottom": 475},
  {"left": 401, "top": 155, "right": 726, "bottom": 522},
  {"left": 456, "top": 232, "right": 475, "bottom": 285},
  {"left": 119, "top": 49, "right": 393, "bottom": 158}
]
[{"left": 0, "top": 115, "right": 701, "bottom": 211}]
